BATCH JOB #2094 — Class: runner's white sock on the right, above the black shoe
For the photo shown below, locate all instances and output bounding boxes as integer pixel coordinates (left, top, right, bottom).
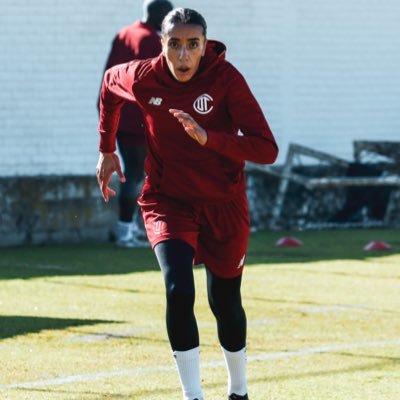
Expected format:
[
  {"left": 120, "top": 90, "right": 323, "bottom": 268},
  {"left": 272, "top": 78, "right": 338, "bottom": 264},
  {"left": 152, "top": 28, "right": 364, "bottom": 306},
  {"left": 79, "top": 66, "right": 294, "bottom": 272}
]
[{"left": 222, "top": 347, "right": 247, "bottom": 396}]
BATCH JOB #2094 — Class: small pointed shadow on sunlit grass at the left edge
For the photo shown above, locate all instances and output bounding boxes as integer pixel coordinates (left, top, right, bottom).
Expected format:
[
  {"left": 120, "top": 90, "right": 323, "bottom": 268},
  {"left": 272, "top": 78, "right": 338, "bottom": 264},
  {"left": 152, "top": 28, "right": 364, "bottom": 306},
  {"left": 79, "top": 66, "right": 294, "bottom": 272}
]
[{"left": 0, "top": 315, "right": 118, "bottom": 339}]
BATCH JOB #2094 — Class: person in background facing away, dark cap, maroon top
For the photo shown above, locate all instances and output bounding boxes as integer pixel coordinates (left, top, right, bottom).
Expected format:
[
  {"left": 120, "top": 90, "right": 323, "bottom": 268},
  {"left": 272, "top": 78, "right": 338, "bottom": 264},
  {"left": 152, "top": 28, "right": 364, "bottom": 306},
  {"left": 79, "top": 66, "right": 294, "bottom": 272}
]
[{"left": 100, "top": 0, "right": 173, "bottom": 247}]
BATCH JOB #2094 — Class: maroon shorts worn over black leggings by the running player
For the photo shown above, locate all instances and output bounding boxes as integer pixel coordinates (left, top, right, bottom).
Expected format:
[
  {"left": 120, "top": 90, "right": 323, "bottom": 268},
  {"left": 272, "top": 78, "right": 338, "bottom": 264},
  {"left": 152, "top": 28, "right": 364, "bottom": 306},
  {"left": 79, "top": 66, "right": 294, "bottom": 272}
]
[{"left": 138, "top": 193, "right": 250, "bottom": 278}]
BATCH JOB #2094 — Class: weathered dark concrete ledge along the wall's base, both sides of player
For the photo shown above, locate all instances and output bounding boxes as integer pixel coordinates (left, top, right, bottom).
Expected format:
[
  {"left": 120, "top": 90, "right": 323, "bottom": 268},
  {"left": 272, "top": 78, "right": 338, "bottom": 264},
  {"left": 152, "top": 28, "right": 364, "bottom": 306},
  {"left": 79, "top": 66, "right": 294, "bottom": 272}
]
[{"left": 0, "top": 166, "right": 400, "bottom": 246}]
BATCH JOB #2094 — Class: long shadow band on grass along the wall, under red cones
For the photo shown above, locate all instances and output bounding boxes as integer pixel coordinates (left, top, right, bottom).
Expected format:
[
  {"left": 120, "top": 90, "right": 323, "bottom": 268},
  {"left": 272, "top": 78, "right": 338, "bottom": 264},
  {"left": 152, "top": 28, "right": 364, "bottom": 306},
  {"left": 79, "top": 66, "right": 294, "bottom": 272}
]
[{"left": 0, "top": 229, "right": 400, "bottom": 280}]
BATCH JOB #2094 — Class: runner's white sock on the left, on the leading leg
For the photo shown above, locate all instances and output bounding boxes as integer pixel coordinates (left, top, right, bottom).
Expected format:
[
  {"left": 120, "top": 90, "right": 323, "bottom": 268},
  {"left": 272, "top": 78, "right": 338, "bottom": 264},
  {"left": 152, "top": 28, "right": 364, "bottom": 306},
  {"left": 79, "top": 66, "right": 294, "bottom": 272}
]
[{"left": 173, "top": 347, "right": 203, "bottom": 400}]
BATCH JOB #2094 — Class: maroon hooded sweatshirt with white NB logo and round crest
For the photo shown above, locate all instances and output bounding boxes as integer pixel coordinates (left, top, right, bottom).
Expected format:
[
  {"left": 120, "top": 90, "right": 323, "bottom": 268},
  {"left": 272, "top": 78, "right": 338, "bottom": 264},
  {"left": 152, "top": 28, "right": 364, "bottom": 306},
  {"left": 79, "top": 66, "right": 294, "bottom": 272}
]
[{"left": 99, "top": 41, "right": 278, "bottom": 203}]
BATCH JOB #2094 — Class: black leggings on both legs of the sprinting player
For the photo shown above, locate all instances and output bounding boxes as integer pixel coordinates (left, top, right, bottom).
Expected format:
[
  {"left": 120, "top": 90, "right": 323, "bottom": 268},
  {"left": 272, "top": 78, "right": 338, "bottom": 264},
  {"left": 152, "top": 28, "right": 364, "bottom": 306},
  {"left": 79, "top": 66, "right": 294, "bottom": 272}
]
[{"left": 155, "top": 240, "right": 246, "bottom": 351}]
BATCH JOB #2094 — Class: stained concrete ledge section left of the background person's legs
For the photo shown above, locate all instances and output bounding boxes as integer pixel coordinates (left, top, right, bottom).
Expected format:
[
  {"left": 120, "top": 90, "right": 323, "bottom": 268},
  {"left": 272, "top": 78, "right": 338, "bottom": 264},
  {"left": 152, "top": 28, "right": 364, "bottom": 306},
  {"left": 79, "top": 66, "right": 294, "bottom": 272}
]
[{"left": 0, "top": 176, "right": 118, "bottom": 246}]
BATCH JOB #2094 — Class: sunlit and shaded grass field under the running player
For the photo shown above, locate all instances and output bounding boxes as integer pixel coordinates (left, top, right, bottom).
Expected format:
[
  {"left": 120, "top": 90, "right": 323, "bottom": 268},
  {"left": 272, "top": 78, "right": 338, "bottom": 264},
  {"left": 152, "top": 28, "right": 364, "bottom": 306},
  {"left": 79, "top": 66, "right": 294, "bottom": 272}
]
[{"left": 0, "top": 230, "right": 400, "bottom": 400}]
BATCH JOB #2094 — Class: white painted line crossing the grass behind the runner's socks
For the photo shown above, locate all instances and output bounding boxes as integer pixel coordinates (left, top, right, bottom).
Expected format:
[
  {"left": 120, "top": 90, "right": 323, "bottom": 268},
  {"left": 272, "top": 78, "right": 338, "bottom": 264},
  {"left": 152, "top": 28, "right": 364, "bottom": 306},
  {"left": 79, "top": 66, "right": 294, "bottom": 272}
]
[{"left": 0, "top": 339, "right": 400, "bottom": 390}]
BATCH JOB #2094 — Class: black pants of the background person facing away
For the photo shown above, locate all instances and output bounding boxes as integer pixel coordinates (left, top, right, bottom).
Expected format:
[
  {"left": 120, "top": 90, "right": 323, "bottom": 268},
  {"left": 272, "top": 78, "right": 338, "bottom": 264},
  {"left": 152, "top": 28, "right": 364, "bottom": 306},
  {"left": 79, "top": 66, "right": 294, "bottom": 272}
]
[{"left": 118, "top": 141, "right": 146, "bottom": 222}]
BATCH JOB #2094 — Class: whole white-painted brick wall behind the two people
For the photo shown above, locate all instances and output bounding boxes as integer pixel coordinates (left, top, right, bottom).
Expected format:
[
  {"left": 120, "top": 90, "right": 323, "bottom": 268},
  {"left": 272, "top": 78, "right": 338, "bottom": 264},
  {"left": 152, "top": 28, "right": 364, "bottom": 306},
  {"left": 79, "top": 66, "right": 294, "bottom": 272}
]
[{"left": 0, "top": 0, "right": 400, "bottom": 176}]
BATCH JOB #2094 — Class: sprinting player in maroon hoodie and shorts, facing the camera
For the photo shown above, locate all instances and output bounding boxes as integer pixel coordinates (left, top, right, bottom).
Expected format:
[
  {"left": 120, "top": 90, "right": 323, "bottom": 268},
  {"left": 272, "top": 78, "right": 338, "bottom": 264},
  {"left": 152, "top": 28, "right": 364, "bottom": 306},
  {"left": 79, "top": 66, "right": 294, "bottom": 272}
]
[{"left": 96, "top": 8, "right": 278, "bottom": 400}]
